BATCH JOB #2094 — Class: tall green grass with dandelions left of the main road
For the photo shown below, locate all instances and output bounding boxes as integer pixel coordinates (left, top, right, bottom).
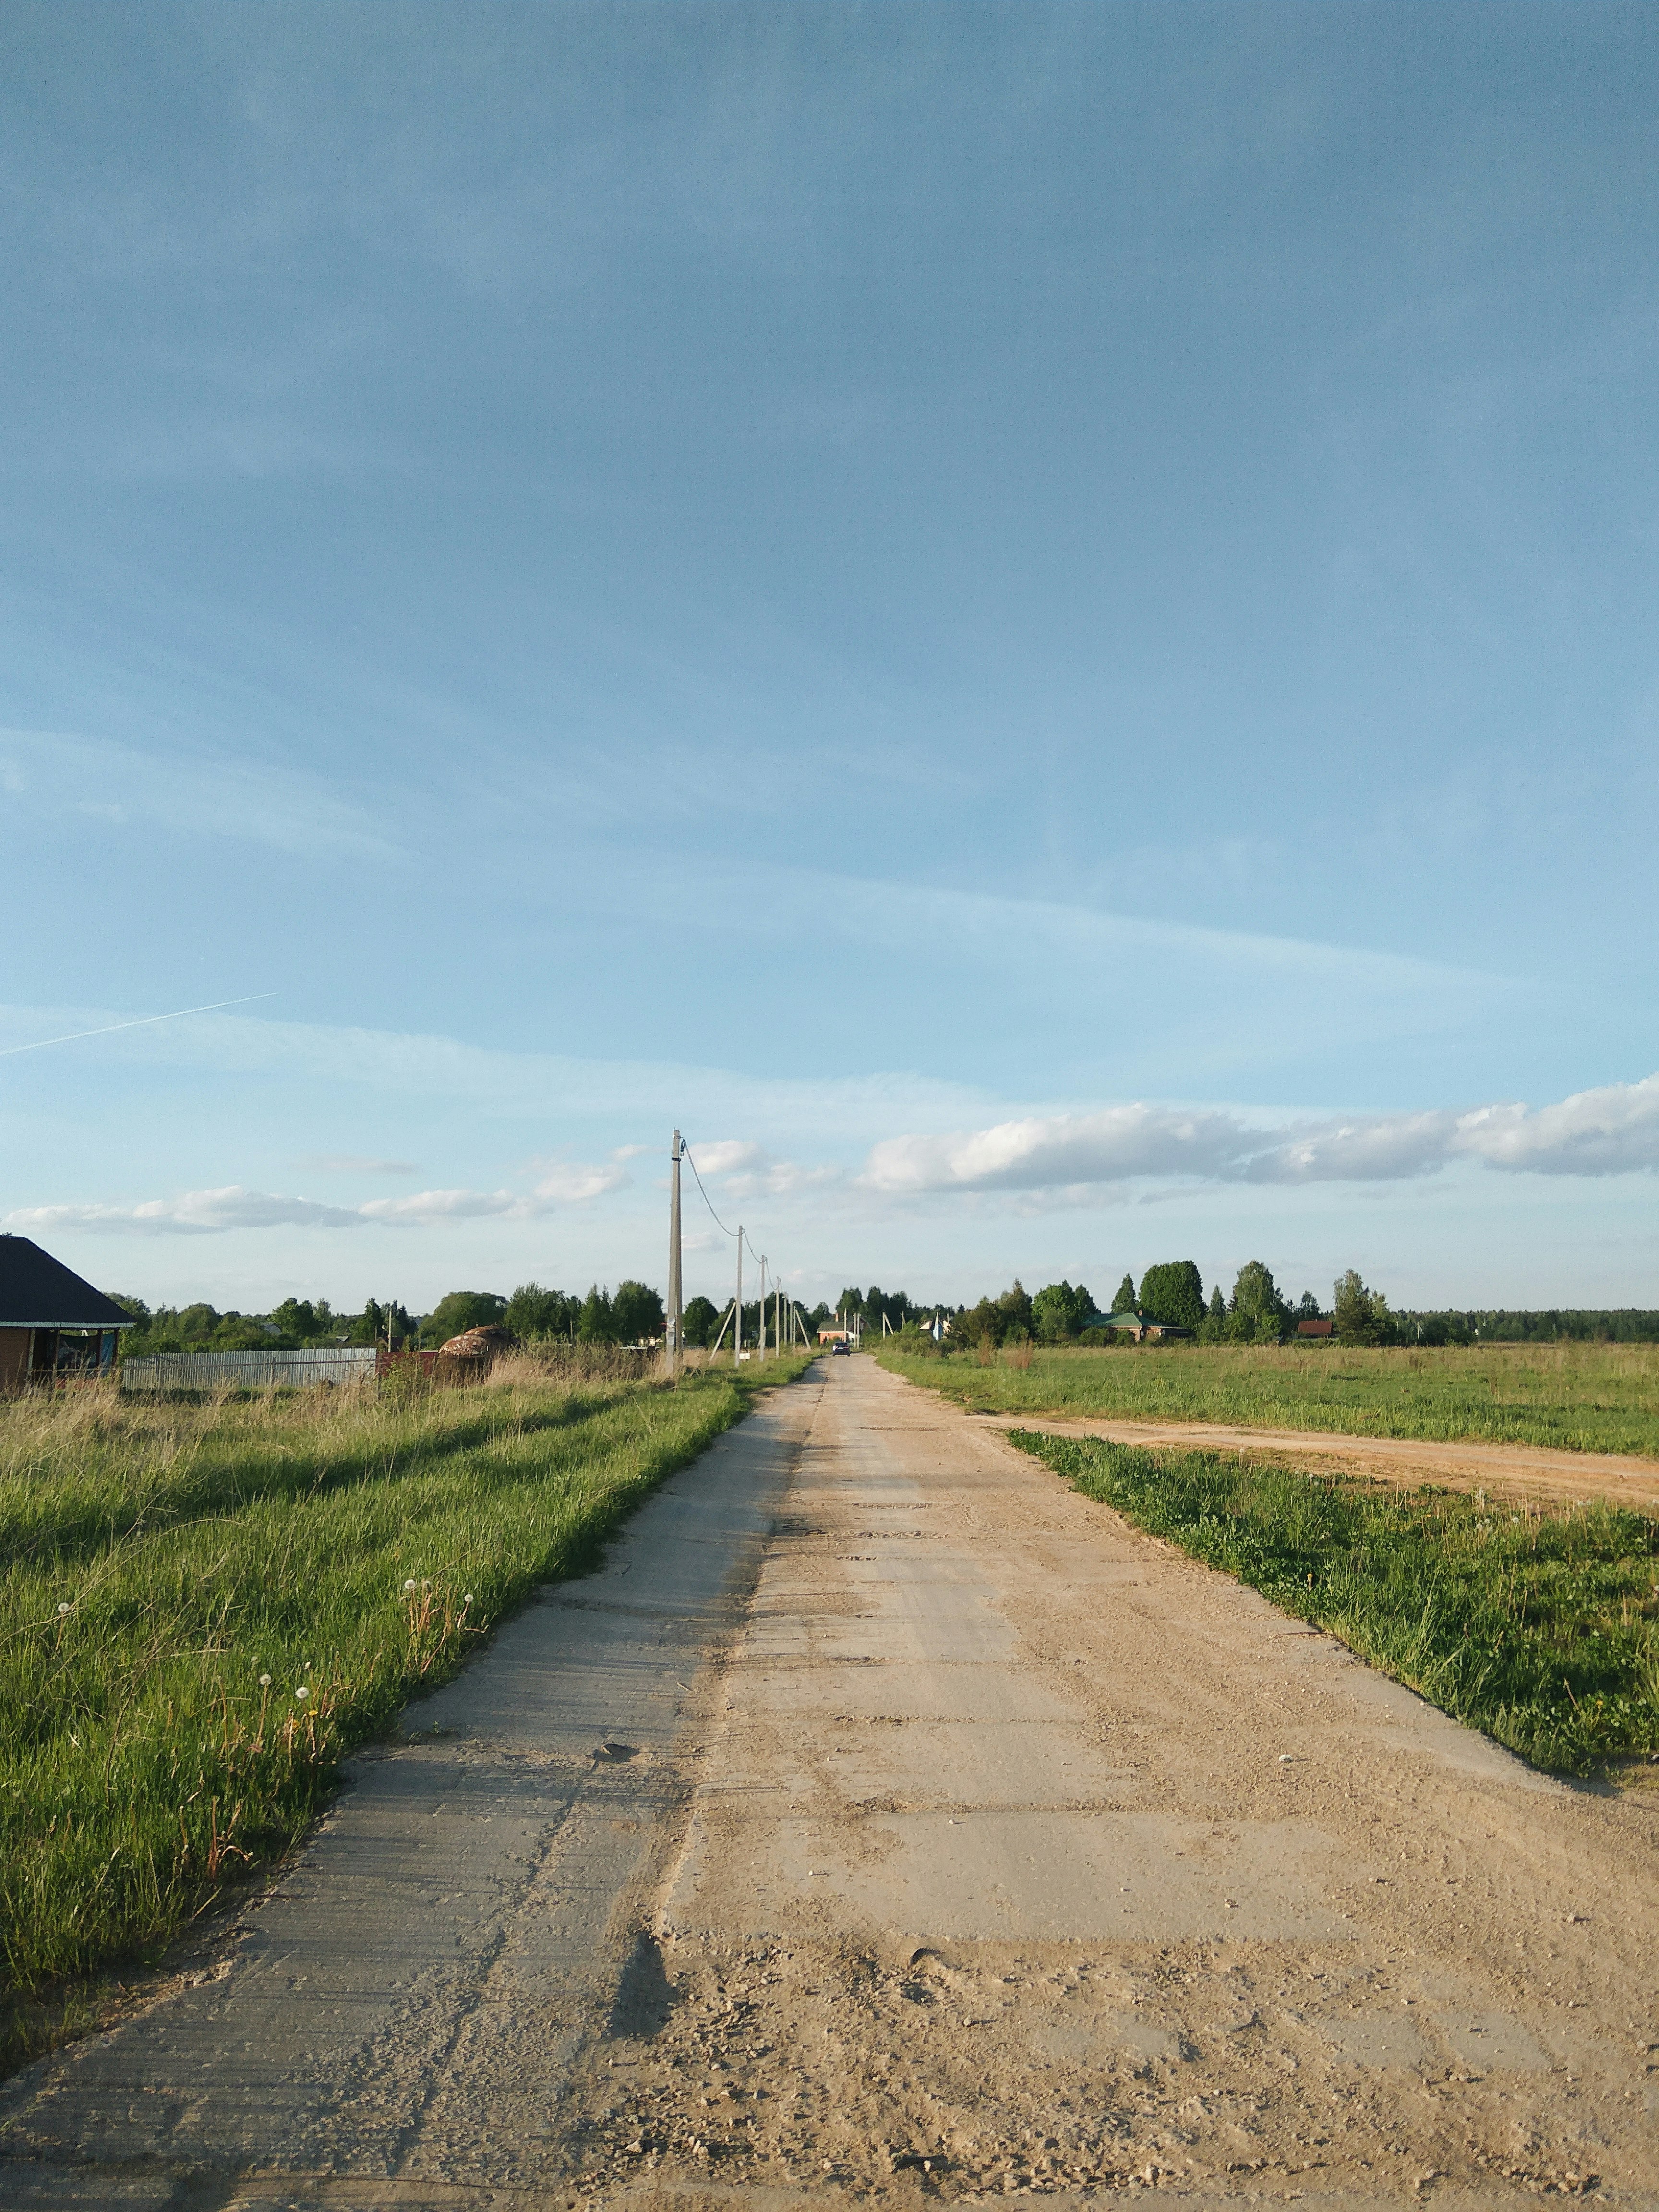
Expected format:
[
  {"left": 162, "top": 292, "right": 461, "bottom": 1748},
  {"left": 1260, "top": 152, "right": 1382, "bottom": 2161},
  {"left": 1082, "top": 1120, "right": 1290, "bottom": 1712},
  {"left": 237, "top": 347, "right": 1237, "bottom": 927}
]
[{"left": 0, "top": 1360, "right": 805, "bottom": 2055}]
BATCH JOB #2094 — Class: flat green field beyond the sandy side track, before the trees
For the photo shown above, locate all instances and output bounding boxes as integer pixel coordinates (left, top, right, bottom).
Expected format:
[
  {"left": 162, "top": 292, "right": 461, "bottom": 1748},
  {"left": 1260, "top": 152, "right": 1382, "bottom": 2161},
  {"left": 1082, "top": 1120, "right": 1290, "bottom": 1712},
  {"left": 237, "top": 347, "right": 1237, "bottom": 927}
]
[{"left": 876, "top": 1345, "right": 1659, "bottom": 1458}]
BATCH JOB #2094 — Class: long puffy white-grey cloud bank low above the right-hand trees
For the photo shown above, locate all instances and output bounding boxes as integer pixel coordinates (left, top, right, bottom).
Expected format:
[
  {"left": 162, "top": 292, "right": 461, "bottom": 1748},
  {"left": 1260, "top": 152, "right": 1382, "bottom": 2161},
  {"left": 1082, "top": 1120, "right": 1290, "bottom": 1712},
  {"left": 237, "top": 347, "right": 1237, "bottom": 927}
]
[{"left": 861, "top": 1075, "right": 1659, "bottom": 1203}]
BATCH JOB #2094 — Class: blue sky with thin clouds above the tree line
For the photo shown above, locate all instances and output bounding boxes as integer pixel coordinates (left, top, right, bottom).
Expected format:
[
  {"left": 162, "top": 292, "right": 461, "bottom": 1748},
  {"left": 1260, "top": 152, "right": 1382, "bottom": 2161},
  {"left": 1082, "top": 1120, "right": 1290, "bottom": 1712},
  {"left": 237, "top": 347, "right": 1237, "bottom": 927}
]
[{"left": 0, "top": 0, "right": 1659, "bottom": 1307}]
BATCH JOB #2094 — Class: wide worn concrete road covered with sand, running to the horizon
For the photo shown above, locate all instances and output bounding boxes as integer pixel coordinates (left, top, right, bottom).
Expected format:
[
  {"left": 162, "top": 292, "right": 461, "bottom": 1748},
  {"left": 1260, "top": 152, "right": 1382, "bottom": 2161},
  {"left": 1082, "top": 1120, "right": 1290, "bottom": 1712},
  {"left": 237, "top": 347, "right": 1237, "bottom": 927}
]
[{"left": 0, "top": 1360, "right": 1659, "bottom": 2212}]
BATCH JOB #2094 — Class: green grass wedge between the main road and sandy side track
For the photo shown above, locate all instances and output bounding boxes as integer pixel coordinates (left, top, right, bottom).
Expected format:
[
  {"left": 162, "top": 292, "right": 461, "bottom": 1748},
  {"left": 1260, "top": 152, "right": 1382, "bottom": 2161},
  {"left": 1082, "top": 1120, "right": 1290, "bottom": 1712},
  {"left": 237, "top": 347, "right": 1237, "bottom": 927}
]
[{"left": 1011, "top": 1429, "right": 1659, "bottom": 1774}]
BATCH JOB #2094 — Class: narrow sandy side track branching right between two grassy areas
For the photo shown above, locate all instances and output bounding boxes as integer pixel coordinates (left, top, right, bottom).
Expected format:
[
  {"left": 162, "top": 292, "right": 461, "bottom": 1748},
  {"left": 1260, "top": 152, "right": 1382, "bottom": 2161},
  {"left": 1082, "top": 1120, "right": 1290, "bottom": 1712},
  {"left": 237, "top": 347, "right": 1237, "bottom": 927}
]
[{"left": 974, "top": 1414, "right": 1659, "bottom": 1513}]
